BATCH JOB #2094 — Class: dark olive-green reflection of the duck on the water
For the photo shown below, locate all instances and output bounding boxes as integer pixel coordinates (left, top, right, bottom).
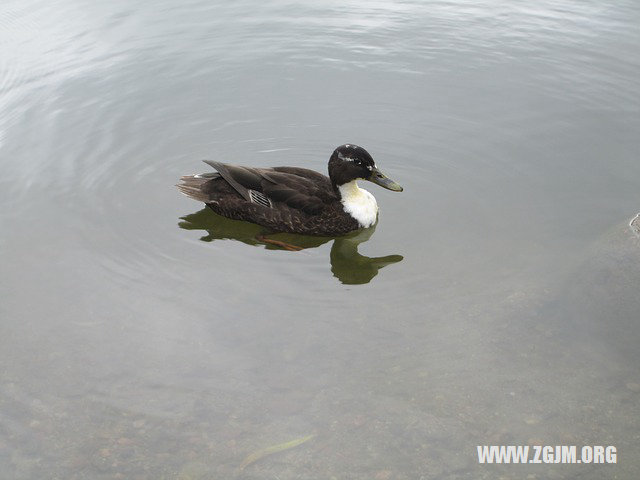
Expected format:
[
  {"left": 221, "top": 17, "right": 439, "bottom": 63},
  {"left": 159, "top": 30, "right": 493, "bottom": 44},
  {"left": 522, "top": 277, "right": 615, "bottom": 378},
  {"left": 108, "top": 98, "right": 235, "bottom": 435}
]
[{"left": 178, "top": 208, "right": 403, "bottom": 285}]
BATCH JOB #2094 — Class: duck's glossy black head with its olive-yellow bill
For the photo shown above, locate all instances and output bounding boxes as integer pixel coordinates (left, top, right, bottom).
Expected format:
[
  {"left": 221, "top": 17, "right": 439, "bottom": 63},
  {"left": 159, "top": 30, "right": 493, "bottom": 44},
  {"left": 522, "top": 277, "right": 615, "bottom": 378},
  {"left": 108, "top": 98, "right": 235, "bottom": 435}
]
[{"left": 329, "top": 143, "right": 402, "bottom": 192}]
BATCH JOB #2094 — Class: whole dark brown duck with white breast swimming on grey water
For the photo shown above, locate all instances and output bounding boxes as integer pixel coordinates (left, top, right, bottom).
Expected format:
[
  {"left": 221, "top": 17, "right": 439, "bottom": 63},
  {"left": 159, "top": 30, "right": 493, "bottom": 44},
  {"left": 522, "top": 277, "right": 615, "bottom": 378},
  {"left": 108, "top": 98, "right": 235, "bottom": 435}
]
[{"left": 177, "top": 144, "right": 402, "bottom": 236}]
